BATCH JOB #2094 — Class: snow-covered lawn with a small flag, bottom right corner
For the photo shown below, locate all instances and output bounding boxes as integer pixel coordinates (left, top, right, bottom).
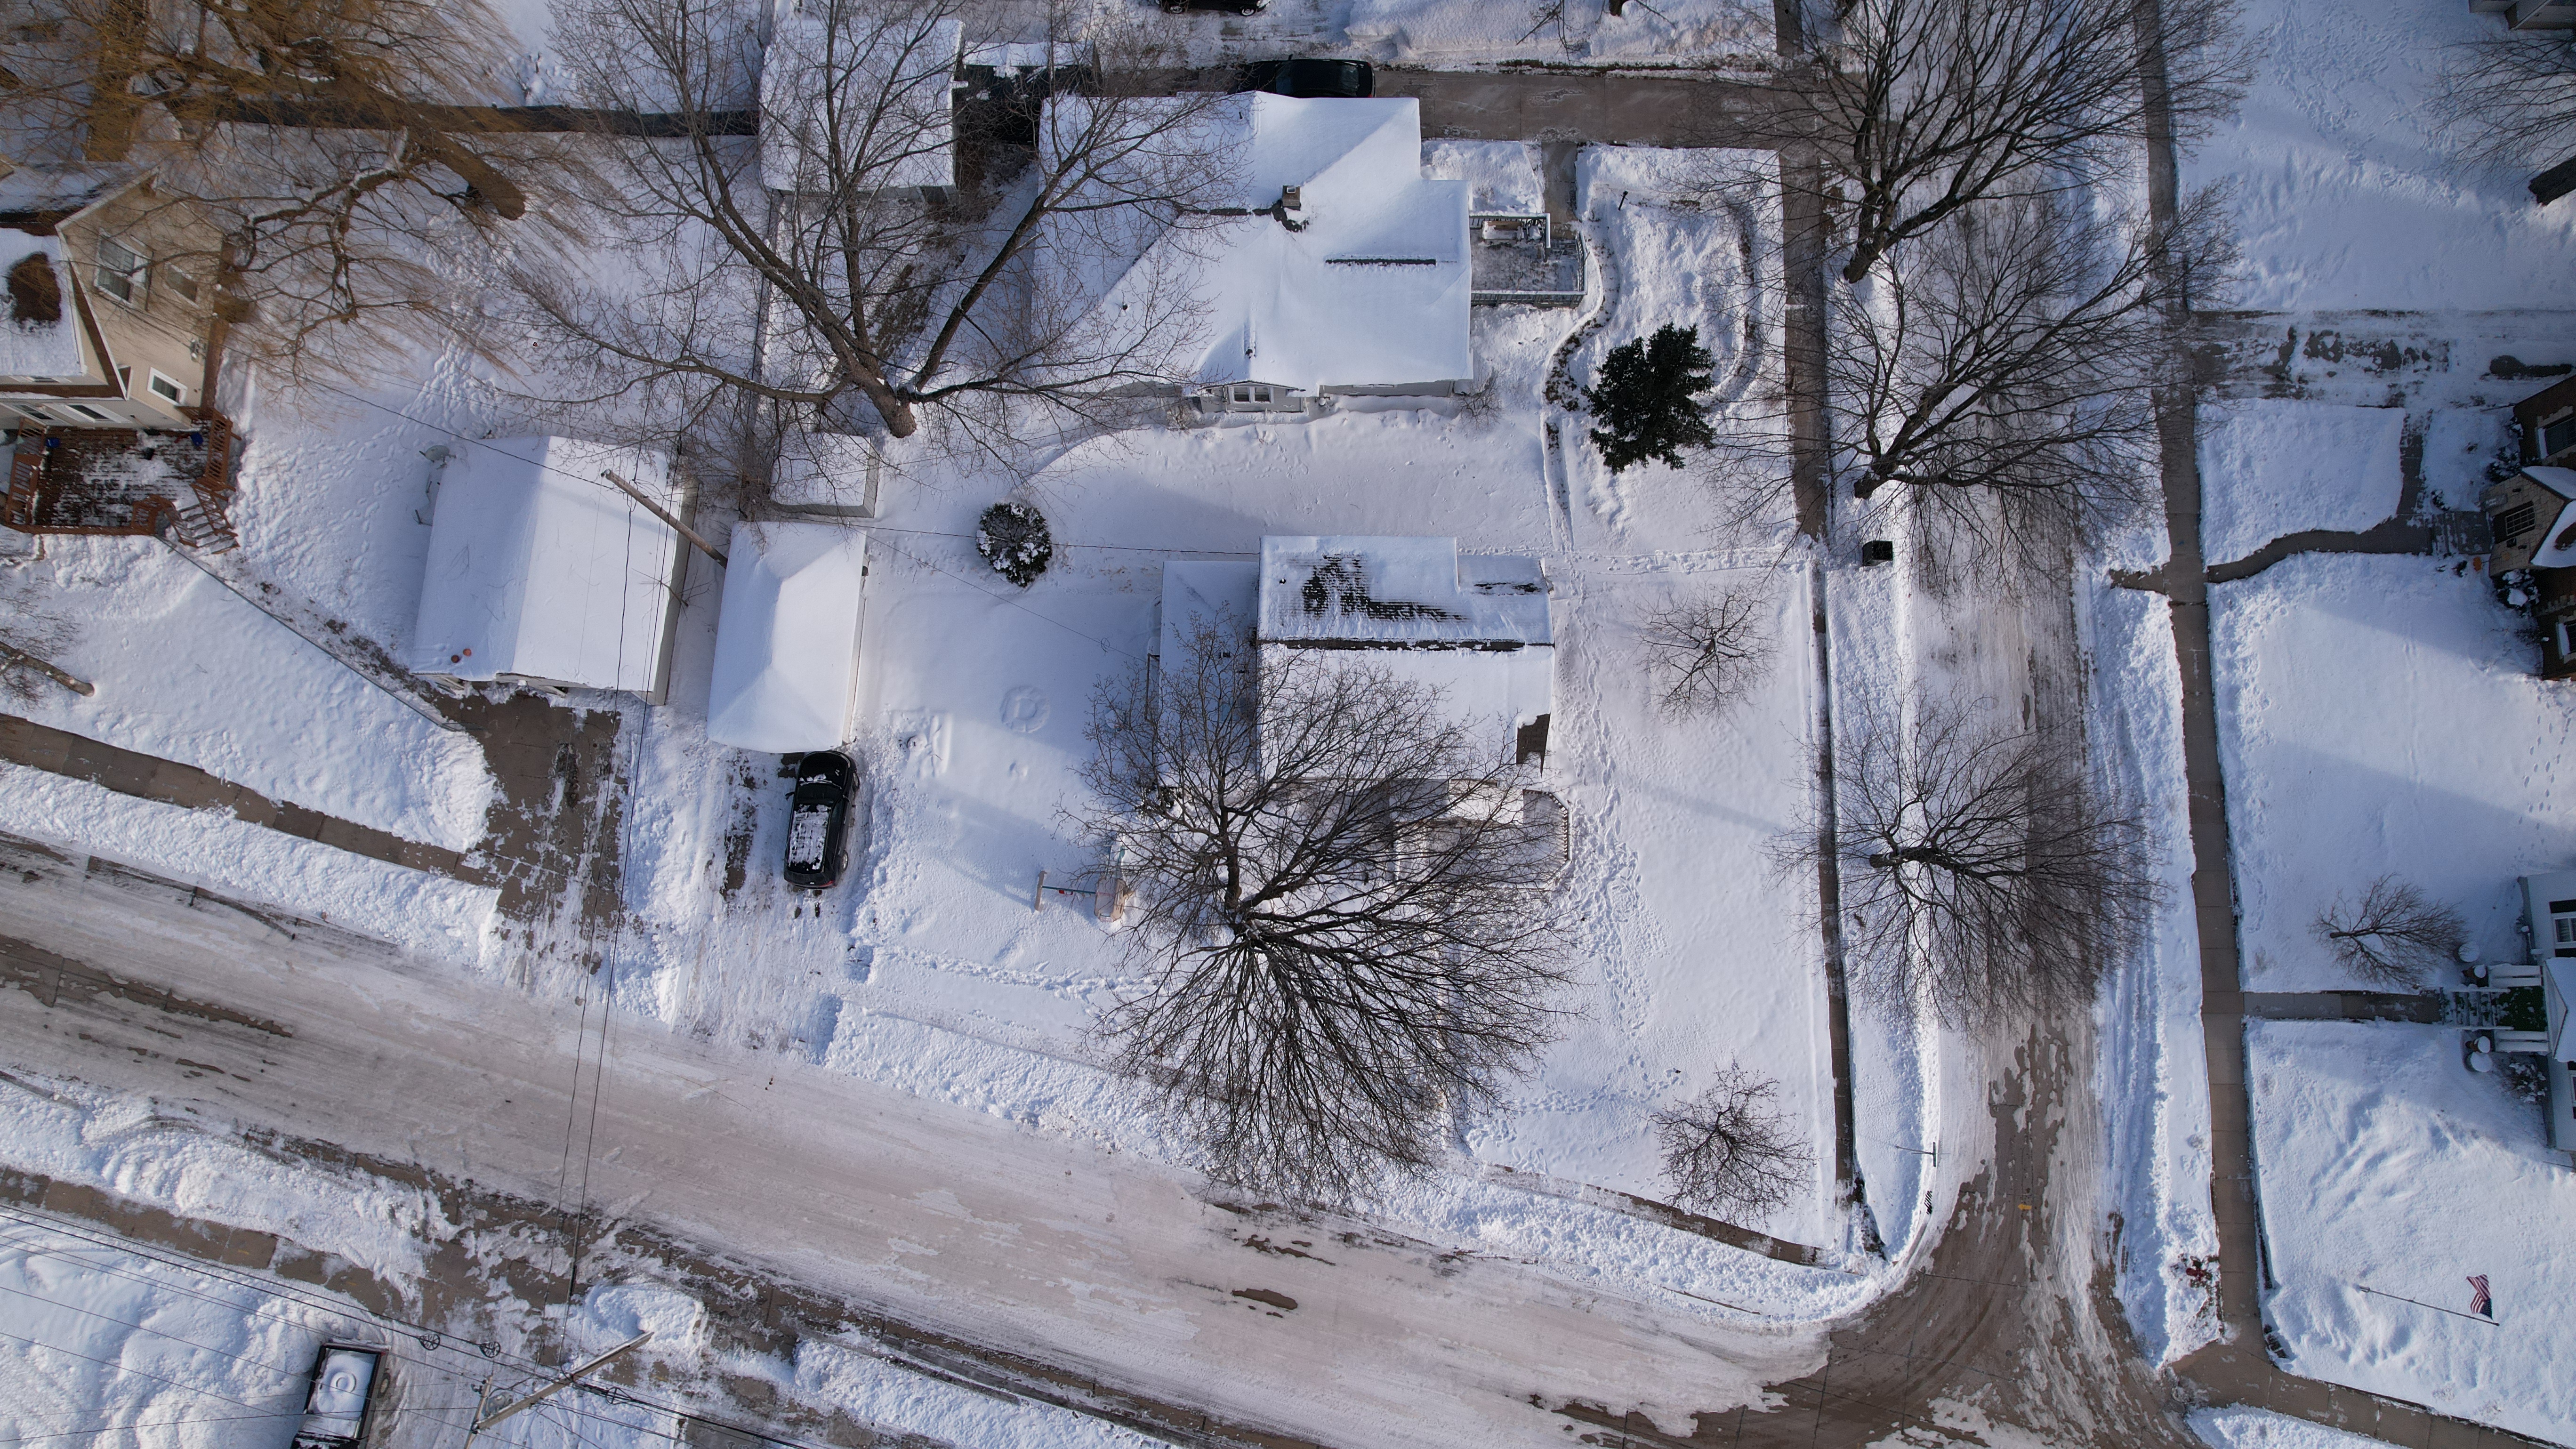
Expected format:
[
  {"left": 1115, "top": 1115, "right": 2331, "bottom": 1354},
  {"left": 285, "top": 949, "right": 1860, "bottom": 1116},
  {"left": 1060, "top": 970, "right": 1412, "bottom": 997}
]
[{"left": 2246, "top": 1021, "right": 2576, "bottom": 1441}]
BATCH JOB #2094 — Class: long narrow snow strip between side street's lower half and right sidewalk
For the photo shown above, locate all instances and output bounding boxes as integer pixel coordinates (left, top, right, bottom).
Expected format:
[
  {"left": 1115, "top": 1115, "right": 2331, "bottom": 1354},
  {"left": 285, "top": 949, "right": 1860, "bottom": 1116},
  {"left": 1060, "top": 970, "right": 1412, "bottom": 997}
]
[{"left": 2079, "top": 572, "right": 2218, "bottom": 1364}]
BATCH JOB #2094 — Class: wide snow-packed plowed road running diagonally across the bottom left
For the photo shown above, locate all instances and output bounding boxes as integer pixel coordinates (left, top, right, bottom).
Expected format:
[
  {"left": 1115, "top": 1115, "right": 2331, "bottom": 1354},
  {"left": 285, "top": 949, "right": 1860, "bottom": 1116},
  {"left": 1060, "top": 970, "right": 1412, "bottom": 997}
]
[{"left": 0, "top": 848, "right": 1824, "bottom": 1449}]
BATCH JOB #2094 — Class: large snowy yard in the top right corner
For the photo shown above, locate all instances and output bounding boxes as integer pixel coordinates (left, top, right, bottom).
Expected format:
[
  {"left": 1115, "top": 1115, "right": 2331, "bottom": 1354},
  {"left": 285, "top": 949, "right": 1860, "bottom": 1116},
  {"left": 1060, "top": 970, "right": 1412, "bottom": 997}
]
[{"left": 2184, "top": 0, "right": 2576, "bottom": 312}]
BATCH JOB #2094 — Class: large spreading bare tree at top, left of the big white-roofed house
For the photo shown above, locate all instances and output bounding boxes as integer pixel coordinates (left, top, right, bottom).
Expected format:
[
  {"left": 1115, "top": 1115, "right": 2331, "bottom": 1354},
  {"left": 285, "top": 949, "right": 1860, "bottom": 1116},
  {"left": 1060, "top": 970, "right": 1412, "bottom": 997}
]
[{"left": 518, "top": 0, "right": 1229, "bottom": 451}]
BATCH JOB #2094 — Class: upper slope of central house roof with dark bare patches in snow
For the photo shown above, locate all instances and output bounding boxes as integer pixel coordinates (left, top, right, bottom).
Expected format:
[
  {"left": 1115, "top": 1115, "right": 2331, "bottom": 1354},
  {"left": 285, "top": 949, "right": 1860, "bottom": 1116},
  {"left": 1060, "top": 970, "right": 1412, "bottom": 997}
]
[{"left": 1260, "top": 534, "right": 1554, "bottom": 650}]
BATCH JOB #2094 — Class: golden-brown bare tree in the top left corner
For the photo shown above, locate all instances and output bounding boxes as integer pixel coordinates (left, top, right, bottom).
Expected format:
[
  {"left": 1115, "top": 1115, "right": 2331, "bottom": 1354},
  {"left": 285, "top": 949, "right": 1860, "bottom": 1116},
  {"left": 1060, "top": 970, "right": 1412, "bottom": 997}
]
[{"left": 0, "top": 0, "right": 567, "bottom": 371}]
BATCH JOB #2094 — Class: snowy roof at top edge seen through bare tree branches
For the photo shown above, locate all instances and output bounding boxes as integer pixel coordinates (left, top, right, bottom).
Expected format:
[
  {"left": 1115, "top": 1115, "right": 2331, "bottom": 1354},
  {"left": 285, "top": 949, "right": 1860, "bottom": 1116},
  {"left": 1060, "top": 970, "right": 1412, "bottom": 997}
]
[{"left": 760, "top": 0, "right": 966, "bottom": 191}]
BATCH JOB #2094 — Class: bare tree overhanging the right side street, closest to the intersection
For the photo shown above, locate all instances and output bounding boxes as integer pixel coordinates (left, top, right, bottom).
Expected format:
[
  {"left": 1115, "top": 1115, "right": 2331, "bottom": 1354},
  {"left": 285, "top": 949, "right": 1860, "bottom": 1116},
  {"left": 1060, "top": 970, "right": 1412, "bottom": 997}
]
[{"left": 1778, "top": 699, "right": 2159, "bottom": 1026}]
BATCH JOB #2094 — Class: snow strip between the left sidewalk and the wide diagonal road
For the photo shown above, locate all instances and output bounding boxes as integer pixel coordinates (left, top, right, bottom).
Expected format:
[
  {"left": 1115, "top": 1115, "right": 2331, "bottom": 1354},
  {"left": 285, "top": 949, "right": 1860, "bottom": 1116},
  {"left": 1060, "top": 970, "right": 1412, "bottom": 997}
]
[{"left": 0, "top": 766, "right": 500, "bottom": 962}]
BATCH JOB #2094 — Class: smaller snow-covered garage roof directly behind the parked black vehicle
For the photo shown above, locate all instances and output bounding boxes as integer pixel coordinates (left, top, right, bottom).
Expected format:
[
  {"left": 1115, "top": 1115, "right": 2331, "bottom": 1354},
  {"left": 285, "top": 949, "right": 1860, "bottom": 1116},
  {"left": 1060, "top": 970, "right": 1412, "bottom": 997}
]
[{"left": 706, "top": 523, "right": 868, "bottom": 756}]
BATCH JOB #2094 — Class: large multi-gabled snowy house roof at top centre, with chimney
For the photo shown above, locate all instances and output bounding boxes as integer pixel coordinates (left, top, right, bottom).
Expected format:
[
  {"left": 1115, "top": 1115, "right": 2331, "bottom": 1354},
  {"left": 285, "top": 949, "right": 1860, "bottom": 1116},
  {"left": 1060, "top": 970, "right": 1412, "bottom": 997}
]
[{"left": 1059, "top": 93, "right": 1476, "bottom": 394}]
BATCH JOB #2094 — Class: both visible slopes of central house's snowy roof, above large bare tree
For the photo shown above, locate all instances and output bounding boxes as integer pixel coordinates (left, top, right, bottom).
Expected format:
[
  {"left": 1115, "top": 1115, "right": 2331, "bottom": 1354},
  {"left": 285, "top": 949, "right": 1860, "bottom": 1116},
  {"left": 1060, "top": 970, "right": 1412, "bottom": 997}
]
[{"left": 1260, "top": 536, "right": 1556, "bottom": 761}]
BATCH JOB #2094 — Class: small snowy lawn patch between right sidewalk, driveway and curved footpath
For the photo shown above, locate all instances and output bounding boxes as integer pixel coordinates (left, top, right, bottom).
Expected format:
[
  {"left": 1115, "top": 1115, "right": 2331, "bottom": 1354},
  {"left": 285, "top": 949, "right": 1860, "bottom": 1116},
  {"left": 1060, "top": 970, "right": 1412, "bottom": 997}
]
[{"left": 2200, "top": 400, "right": 2406, "bottom": 564}]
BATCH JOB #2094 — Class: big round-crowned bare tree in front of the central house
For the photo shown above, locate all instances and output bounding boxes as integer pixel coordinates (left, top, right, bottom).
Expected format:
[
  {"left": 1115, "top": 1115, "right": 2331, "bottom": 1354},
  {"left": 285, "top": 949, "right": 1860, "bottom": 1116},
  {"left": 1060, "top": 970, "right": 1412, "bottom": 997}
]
[{"left": 1082, "top": 619, "right": 1571, "bottom": 1201}]
